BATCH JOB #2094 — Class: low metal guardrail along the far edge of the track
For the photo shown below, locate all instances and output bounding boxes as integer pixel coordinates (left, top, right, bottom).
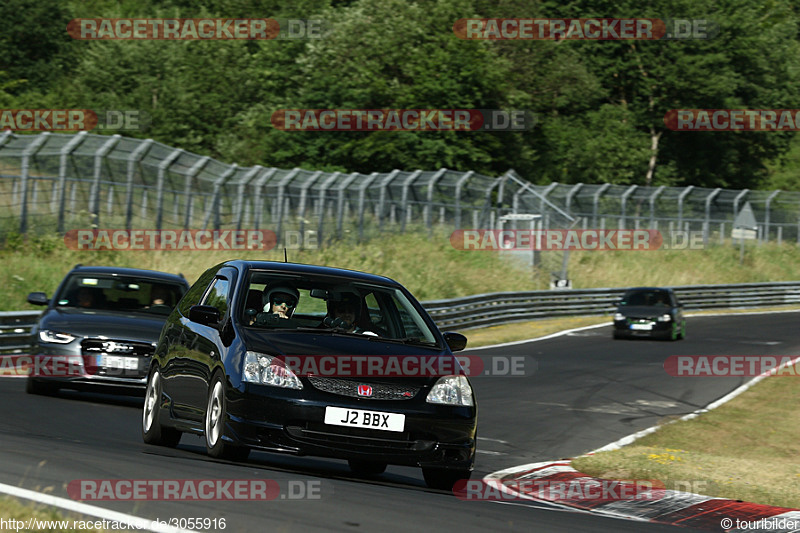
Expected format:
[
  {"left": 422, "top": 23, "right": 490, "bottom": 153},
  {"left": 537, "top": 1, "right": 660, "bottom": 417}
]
[{"left": 0, "top": 281, "right": 800, "bottom": 354}]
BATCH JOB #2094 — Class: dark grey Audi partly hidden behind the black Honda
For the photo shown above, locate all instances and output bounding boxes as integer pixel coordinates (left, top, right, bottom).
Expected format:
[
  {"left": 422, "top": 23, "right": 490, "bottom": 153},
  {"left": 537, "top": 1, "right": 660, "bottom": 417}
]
[{"left": 26, "top": 265, "right": 189, "bottom": 394}]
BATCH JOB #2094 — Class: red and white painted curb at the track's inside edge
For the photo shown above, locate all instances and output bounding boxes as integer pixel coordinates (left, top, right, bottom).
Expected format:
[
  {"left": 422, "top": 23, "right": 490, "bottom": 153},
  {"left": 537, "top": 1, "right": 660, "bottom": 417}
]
[{"left": 484, "top": 460, "right": 800, "bottom": 532}]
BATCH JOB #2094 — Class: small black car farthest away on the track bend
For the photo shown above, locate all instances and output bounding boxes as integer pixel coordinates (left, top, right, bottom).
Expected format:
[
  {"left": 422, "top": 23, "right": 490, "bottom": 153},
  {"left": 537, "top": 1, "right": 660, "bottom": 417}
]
[{"left": 614, "top": 287, "right": 686, "bottom": 340}]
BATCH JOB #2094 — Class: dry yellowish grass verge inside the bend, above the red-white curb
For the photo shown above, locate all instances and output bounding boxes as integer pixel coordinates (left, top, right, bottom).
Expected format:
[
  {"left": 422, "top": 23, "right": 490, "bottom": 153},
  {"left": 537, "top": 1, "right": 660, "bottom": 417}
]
[{"left": 573, "top": 367, "right": 800, "bottom": 508}]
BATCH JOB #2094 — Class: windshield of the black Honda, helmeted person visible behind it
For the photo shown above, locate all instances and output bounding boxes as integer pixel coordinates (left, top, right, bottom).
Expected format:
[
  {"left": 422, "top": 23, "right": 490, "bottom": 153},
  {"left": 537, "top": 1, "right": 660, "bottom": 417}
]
[{"left": 239, "top": 271, "right": 436, "bottom": 344}]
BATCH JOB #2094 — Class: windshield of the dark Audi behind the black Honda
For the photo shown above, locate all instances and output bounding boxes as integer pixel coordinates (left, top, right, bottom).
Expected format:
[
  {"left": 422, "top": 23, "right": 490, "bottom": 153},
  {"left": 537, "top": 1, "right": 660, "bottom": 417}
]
[{"left": 54, "top": 274, "right": 185, "bottom": 315}]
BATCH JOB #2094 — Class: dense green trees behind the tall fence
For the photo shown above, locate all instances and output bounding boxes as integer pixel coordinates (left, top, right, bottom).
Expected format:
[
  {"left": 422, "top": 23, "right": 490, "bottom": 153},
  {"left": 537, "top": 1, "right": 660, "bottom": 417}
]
[{"left": 0, "top": 0, "right": 800, "bottom": 189}]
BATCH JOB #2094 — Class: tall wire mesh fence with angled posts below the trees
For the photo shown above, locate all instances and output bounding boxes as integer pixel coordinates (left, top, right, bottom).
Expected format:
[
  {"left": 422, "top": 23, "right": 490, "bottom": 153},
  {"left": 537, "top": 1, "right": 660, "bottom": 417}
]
[{"left": 0, "top": 132, "right": 800, "bottom": 243}]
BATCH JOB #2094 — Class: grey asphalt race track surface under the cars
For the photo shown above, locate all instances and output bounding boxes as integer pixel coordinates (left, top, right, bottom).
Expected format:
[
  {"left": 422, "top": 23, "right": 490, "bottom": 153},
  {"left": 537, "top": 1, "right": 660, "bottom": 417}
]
[{"left": 0, "top": 313, "right": 800, "bottom": 532}]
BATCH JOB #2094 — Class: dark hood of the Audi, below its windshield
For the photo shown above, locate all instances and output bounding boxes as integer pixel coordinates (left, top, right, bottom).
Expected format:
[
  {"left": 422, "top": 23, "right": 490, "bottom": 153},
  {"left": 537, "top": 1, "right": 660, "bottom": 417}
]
[{"left": 39, "top": 308, "right": 167, "bottom": 342}]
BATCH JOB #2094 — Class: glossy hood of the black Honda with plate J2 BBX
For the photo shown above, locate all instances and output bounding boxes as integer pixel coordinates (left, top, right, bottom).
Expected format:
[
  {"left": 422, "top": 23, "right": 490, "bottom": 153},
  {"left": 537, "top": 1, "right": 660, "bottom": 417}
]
[{"left": 242, "top": 329, "right": 459, "bottom": 384}]
